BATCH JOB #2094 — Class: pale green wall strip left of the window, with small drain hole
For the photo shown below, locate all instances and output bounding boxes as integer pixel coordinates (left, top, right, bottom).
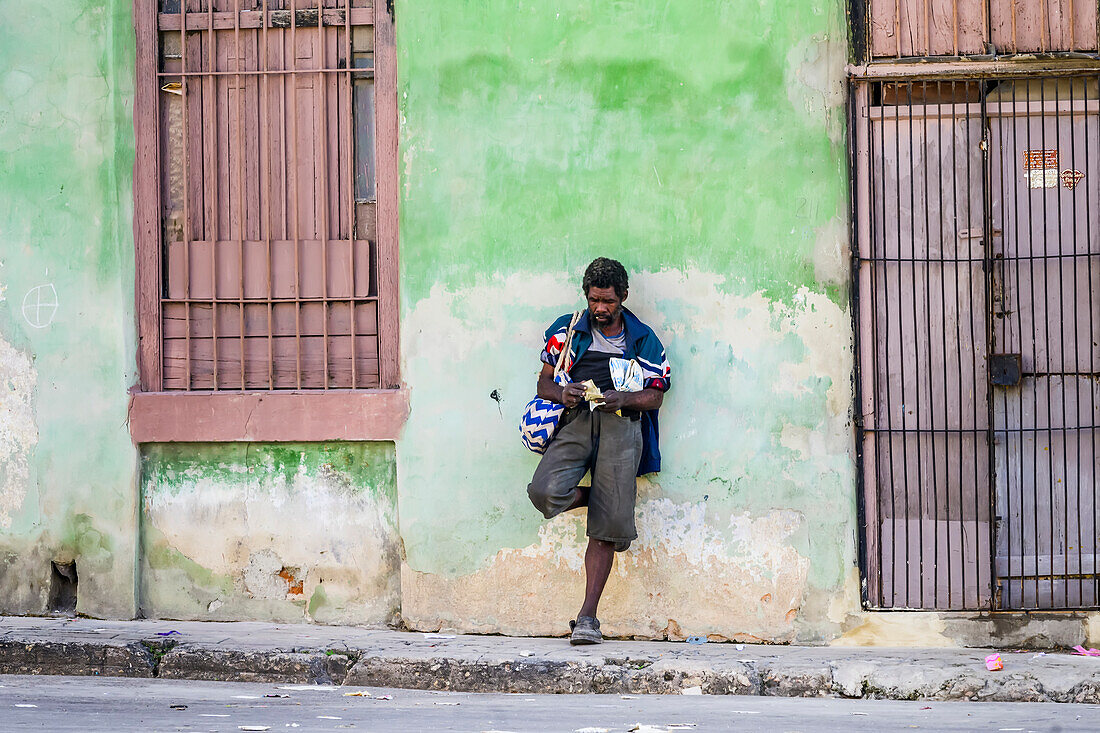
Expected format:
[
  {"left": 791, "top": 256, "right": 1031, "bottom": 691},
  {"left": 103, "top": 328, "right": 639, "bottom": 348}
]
[{"left": 0, "top": 0, "right": 138, "bottom": 617}]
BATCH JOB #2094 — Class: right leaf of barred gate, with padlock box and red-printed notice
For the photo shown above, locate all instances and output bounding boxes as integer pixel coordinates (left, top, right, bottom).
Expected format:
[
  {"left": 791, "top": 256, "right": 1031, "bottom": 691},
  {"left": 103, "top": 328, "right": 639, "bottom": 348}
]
[{"left": 987, "top": 77, "right": 1100, "bottom": 609}]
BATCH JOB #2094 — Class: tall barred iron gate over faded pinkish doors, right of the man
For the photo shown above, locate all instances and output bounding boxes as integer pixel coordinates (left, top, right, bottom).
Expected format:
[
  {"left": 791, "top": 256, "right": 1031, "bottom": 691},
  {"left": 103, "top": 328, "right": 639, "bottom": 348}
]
[{"left": 850, "top": 72, "right": 1100, "bottom": 610}]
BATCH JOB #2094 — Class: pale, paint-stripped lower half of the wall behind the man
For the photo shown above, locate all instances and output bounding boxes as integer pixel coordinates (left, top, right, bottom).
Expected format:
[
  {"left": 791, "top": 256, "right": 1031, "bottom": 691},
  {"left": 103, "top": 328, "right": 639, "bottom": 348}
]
[{"left": 398, "top": 260, "right": 855, "bottom": 642}]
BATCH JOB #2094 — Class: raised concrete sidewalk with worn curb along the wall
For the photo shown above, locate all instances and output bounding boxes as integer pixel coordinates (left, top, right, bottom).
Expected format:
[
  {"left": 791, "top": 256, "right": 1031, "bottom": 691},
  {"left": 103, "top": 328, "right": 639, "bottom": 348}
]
[{"left": 0, "top": 616, "right": 1100, "bottom": 703}]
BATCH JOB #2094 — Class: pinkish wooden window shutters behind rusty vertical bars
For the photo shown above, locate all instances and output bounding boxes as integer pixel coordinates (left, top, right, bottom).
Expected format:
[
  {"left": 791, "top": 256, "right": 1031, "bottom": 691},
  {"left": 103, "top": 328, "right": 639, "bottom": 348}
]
[{"left": 156, "top": 0, "right": 380, "bottom": 391}]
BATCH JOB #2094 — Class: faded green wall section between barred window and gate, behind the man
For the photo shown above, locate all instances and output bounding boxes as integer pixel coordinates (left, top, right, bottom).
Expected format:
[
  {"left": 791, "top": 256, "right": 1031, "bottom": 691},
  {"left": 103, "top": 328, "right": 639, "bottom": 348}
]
[{"left": 397, "top": 0, "right": 858, "bottom": 642}]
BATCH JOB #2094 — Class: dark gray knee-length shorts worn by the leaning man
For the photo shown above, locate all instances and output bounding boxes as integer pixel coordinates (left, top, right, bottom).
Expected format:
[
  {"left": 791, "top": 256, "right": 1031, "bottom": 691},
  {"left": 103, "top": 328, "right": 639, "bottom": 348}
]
[{"left": 527, "top": 403, "right": 641, "bottom": 553}]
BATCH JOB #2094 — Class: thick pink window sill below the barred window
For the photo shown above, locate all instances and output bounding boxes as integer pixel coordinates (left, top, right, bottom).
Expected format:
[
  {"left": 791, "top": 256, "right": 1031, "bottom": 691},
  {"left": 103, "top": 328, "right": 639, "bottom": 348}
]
[{"left": 130, "top": 390, "right": 409, "bottom": 445}]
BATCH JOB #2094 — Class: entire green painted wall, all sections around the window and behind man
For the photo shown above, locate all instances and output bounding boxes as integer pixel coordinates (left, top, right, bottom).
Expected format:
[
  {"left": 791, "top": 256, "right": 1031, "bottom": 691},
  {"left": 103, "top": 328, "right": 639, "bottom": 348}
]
[{"left": 0, "top": 0, "right": 858, "bottom": 641}]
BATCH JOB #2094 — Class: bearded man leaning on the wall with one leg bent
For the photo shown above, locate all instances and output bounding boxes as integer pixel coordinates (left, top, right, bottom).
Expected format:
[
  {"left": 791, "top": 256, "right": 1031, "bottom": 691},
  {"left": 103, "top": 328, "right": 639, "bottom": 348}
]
[{"left": 527, "top": 258, "right": 670, "bottom": 644}]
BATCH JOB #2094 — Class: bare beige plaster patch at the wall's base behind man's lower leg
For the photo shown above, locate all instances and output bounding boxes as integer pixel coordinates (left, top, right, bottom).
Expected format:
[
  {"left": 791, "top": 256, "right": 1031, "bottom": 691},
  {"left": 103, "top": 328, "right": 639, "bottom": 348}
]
[{"left": 403, "top": 490, "right": 809, "bottom": 642}]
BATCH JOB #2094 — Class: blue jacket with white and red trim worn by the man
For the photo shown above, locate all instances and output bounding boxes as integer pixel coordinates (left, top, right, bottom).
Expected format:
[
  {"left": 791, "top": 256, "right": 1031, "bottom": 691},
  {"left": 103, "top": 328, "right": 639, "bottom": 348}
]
[{"left": 541, "top": 308, "right": 672, "bottom": 475}]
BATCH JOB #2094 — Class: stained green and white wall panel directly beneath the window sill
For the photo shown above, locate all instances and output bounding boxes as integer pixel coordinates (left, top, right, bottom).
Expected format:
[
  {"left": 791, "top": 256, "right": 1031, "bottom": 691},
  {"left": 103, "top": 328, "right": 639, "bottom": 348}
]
[{"left": 141, "top": 442, "right": 399, "bottom": 624}]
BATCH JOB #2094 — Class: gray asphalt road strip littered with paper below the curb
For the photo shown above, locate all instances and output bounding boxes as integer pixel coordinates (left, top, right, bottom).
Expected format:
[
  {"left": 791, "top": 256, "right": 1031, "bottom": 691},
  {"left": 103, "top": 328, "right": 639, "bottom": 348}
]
[{"left": 0, "top": 676, "right": 1100, "bottom": 733}]
